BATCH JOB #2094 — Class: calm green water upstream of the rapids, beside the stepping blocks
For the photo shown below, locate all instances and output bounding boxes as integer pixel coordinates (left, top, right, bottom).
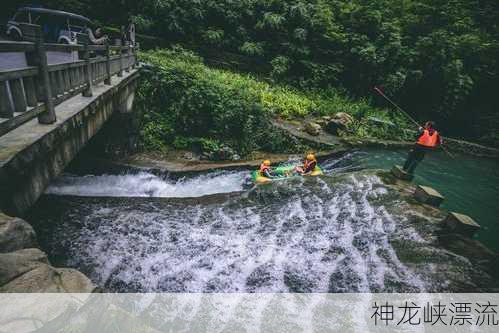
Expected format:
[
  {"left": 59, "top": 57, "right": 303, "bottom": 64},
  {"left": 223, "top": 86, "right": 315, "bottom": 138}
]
[{"left": 352, "top": 149, "right": 499, "bottom": 252}]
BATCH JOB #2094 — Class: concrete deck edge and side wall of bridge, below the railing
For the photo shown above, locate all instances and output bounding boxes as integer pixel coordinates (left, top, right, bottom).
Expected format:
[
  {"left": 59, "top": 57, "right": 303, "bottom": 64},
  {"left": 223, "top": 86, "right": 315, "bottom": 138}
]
[{"left": 0, "top": 69, "right": 139, "bottom": 216}]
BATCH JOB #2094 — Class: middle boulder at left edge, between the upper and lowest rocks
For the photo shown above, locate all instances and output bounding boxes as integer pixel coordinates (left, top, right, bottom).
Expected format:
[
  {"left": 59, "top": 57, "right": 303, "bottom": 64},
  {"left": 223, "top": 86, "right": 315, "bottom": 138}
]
[{"left": 0, "top": 249, "right": 49, "bottom": 286}]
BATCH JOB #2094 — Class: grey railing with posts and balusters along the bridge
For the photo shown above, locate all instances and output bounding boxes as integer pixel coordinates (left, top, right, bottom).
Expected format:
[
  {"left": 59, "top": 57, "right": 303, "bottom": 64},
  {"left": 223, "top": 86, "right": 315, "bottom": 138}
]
[{"left": 0, "top": 25, "right": 138, "bottom": 136}]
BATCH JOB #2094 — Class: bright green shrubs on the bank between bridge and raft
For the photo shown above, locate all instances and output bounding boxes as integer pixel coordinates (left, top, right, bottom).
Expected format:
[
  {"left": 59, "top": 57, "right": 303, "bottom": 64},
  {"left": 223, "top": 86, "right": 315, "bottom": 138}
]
[{"left": 136, "top": 48, "right": 406, "bottom": 155}]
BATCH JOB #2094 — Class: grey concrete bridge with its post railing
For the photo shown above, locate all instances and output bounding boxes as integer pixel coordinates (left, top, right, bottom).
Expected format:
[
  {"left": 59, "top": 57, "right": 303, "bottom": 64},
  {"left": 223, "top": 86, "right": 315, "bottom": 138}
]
[{"left": 0, "top": 24, "right": 139, "bottom": 216}]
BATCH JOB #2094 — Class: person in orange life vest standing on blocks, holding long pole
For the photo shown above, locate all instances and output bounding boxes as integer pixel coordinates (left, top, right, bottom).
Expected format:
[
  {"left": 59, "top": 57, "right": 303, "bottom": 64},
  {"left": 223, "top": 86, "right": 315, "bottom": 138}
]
[{"left": 404, "top": 121, "right": 443, "bottom": 175}]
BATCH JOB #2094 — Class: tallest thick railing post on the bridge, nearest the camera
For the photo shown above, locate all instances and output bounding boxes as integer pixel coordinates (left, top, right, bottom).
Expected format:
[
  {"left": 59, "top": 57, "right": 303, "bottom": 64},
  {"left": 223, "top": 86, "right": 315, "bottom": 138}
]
[{"left": 25, "top": 26, "right": 57, "bottom": 124}]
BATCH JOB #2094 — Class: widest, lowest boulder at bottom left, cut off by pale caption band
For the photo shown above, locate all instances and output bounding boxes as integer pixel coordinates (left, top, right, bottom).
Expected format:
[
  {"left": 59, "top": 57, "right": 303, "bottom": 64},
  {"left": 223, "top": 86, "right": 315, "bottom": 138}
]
[{"left": 0, "top": 264, "right": 95, "bottom": 293}]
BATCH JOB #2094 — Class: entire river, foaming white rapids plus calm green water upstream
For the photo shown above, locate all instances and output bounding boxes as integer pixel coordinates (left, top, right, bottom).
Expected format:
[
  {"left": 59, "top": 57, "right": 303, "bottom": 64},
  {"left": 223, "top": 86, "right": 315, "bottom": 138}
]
[{"left": 30, "top": 150, "right": 499, "bottom": 292}]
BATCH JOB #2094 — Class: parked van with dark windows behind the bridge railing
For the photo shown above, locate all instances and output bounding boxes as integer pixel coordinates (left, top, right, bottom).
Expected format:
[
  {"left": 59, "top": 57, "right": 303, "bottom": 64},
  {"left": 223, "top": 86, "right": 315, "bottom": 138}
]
[{"left": 7, "top": 7, "right": 91, "bottom": 44}]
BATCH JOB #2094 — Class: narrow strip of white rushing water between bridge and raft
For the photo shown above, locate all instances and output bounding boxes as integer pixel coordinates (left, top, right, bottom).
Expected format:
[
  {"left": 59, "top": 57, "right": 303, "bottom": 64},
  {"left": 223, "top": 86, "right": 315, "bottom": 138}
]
[{"left": 45, "top": 171, "right": 248, "bottom": 198}]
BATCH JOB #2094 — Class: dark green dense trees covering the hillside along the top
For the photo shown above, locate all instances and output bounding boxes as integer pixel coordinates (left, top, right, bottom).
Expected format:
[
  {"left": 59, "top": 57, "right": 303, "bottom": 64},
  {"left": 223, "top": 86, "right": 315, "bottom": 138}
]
[{"left": 4, "top": 0, "right": 499, "bottom": 143}]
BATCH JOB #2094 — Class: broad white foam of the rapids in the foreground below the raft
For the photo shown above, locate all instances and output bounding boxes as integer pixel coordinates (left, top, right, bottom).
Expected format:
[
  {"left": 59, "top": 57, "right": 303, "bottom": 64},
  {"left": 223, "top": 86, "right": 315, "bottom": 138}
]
[{"left": 44, "top": 173, "right": 434, "bottom": 292}]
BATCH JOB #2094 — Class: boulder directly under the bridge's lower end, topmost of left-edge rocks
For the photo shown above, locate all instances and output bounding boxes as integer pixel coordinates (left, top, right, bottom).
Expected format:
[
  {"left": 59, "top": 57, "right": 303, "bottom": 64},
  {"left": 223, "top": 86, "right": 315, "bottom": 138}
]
[{"left": 0, "top": 213, "right": 36, "bottom": 252}]
